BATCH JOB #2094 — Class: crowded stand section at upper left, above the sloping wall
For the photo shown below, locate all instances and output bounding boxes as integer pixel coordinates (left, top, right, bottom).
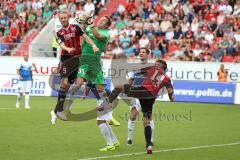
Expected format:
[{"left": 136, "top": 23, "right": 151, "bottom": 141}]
[{"left": 0, "top": 0, "right": 105, "bottom": 56}]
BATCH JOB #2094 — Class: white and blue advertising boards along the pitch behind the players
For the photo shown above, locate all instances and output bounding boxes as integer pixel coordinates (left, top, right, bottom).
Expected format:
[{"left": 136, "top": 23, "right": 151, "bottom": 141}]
[{"left": 0, "top": 57, "right": 240, "bottom": 104}]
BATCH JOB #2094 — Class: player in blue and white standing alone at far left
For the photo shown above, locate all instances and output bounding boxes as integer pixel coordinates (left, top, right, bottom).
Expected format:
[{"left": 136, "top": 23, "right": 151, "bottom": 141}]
[{"left": 16, "top": 52, "right": 32, "bottom": 109}]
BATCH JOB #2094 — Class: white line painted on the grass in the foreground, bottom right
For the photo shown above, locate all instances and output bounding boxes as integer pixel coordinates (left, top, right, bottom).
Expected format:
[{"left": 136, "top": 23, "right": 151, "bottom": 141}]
[{"left": 78, "top": 142, "right": 240, "bottom": 160}]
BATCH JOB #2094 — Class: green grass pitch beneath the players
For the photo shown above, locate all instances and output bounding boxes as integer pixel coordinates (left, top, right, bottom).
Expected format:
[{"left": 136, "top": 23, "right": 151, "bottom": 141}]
[{"left": 0, "top": 96, "right": 240, "bottom": 160}]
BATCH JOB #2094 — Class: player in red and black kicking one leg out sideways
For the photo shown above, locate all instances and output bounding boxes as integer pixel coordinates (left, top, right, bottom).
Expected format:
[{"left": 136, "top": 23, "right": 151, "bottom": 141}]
[{"left": 99, "top": 60, "right": 174, "bottom": 154}]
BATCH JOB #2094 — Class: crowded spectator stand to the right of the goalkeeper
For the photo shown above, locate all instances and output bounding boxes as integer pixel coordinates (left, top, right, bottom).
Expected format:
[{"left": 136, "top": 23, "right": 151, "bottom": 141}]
[{"left": 107, "top": 0, "right": 240, "bottom": 62}]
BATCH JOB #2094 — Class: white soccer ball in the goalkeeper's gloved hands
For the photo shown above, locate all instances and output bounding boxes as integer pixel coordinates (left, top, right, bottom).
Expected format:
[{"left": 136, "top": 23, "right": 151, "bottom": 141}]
[{"left": 75, "top": 11, "right": 93, "bottom": 25}]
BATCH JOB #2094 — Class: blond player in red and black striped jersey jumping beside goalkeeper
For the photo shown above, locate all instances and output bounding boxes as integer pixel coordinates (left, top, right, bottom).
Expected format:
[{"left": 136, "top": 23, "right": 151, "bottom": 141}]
[{"left": 51, "top": 11, "right": 99, "bottom": 124}]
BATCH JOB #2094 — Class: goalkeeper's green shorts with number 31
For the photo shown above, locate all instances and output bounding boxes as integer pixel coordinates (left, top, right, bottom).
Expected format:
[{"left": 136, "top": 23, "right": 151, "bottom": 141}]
[{"left": 77, "top": 55, "right": 105, "bottom": 84}]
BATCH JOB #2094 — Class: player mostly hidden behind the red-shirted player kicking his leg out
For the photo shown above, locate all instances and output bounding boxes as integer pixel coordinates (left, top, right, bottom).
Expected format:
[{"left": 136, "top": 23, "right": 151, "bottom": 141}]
[{"left": 127, "top": 48, "right": 154, "bottom": 145}]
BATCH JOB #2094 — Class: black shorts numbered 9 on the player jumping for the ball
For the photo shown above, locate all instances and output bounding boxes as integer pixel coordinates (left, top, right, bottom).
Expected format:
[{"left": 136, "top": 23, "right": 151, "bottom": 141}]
[{"left": 60, "top": 56, "right": 80, "bottom": 84}]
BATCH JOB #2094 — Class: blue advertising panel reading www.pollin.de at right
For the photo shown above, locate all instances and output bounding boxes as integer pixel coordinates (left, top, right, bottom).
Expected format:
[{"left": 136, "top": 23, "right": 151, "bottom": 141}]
[{"left": 173, "top": 81, "right": 235, "bottom": 104}]
